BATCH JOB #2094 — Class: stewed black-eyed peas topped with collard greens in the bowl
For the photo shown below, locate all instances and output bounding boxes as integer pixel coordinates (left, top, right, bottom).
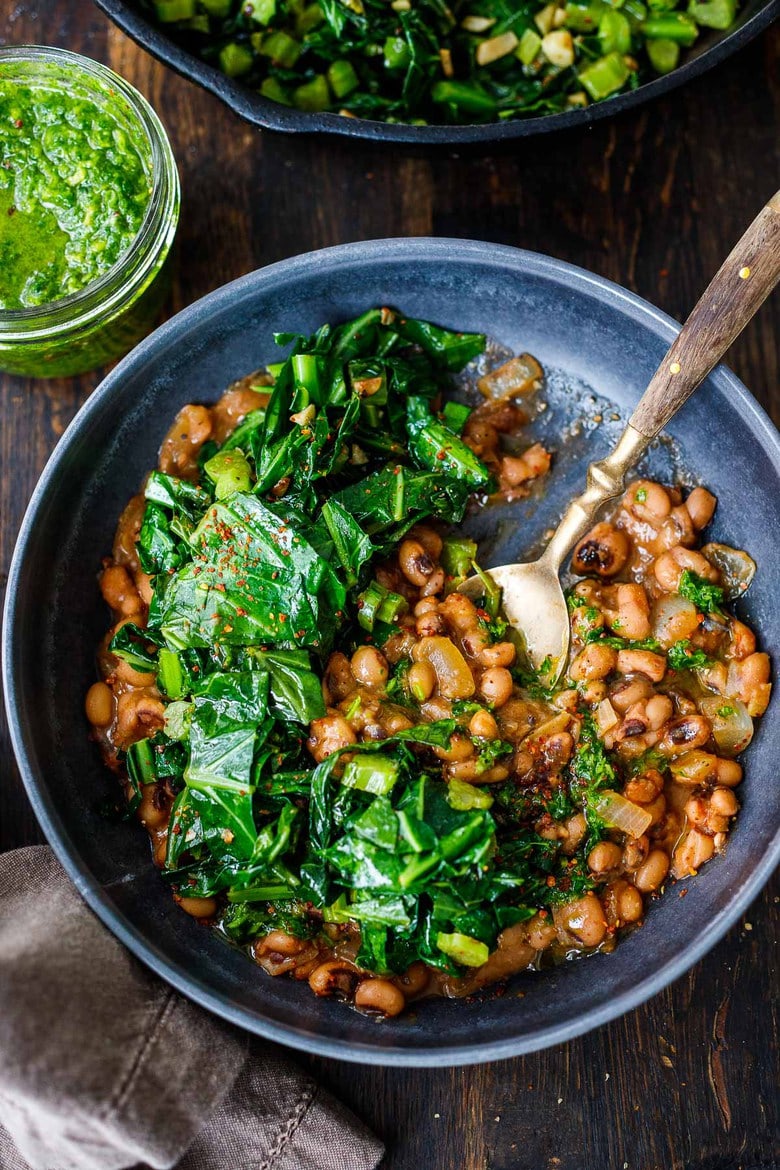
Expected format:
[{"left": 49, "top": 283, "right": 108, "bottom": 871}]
[{"left": 85, "top": 309, "right": 771, "bottom": 1018}]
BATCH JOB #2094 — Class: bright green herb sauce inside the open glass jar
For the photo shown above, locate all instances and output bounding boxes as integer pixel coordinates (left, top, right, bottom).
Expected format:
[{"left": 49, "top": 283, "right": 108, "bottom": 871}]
[{"left": 0, "top": 78, "right": 152, "bottom": 310}]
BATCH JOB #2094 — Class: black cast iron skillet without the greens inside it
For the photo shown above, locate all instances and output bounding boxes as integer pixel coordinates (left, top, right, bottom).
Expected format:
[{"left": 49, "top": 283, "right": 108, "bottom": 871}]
[{"left": 96, "top": 0, "right": 780, "bottom": 145}]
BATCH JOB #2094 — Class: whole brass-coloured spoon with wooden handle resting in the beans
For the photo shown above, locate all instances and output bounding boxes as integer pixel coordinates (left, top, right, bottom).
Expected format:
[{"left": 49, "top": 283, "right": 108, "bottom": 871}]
[{"left": 460, "top": 191, "right": 780, "bottom": 683}]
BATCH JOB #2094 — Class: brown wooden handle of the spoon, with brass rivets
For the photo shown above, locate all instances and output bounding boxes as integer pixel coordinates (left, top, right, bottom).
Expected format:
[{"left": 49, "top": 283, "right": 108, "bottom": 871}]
[{"left": 629, "top": 191, "right": 780, "bottom": 439}]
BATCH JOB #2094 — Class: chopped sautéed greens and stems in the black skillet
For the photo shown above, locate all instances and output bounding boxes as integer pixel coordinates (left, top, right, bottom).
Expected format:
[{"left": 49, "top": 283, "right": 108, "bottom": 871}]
[{"left": 143, "top": 0, "right": 737, "bottom": 125}]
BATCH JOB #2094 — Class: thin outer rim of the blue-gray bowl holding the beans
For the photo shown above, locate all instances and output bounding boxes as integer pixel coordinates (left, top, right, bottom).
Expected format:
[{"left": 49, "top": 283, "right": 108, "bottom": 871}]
[{"left": 2, "top": 236, "right": 780, "bottom": 1068}]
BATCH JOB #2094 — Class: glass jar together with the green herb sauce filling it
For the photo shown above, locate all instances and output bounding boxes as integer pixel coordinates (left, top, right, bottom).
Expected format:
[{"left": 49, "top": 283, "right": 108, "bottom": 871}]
[{"left": 0, "top": 46, "right": 179, "bottom": 378}]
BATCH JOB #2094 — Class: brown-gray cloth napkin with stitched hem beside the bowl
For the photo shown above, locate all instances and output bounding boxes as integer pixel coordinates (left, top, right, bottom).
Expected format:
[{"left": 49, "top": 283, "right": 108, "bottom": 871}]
[{"left": 0, "top": 846, "right": 382, "bottom": 1170}]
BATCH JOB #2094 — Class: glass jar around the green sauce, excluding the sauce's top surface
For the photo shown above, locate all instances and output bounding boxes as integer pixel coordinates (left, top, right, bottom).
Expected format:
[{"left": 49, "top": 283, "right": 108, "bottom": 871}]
[{"left": 0, "top": 46, "right": 180, "bottom": 378}]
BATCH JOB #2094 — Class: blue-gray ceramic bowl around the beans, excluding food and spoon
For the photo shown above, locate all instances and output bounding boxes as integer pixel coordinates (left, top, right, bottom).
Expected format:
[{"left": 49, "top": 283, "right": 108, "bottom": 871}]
[{"left": 4, "top": 239, "right": 780, "bottom": 1065}]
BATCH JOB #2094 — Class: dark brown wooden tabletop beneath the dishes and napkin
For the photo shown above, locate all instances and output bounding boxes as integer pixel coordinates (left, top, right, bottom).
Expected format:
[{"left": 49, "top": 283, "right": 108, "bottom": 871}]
[{"left": 0, "top": 0, "right": 780, "bottom": 1170}]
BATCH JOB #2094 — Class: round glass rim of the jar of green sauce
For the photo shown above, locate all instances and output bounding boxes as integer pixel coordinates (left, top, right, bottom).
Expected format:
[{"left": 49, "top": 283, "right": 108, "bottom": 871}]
[{"left": 0, "top": 44, "right": 180, "bottom": 344}]
